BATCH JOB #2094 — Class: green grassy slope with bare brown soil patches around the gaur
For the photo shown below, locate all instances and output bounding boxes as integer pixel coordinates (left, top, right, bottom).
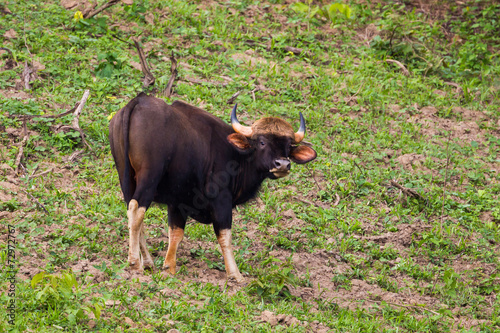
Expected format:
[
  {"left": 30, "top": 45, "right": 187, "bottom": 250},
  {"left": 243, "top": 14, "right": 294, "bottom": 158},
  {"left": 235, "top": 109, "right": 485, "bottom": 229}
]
[{"left": 0, "top": 0, "right": 500, "bottom": 332}]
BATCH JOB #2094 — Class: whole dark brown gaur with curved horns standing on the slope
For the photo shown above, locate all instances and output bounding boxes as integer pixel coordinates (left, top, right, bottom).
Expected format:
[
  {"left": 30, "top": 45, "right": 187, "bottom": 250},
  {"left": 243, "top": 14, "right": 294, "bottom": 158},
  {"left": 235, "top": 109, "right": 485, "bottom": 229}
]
[{"left": 109, "top": 93, "right": 316, "bottom": 282}]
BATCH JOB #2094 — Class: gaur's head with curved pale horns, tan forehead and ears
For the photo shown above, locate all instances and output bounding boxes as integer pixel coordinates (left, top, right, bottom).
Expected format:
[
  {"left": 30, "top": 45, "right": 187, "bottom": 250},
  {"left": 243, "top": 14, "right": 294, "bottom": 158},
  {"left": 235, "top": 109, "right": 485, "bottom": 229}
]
[{"left": 227, "top": 105, "right": 316, "bottom": 179}]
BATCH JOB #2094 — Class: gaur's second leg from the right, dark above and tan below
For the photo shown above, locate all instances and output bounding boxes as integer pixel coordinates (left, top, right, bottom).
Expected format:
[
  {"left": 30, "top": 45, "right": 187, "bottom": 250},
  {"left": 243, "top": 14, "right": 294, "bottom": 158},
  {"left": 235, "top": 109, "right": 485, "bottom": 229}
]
[{"left": 163, "top": 207, "right": 186, "bottom": 274}]
